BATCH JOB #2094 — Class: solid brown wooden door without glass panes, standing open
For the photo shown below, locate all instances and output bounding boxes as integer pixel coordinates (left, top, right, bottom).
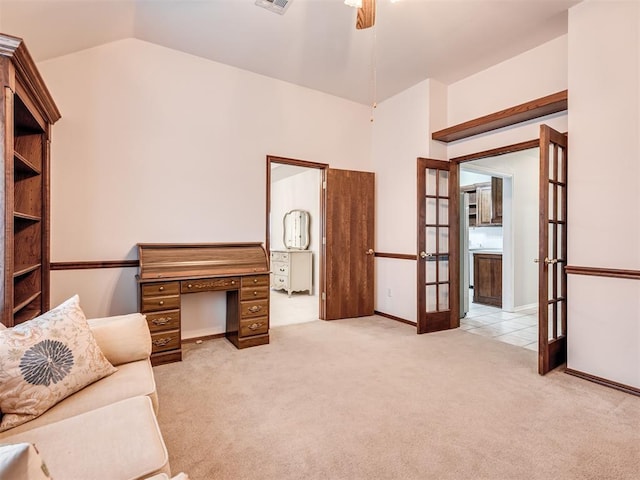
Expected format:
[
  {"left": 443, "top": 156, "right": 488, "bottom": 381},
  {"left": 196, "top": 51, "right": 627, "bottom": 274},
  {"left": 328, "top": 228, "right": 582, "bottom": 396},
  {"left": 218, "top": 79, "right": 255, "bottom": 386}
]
[{"left": 320, "top": 168, "right": 375, "bottom": 320}]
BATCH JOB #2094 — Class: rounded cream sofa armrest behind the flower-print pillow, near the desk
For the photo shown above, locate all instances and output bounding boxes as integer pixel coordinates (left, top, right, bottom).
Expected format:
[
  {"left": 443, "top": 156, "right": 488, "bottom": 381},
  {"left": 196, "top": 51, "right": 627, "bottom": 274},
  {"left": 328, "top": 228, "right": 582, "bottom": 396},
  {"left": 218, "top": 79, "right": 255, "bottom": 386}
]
[{"left": 88, "top": 313, "right": 151, "bottom": 365}]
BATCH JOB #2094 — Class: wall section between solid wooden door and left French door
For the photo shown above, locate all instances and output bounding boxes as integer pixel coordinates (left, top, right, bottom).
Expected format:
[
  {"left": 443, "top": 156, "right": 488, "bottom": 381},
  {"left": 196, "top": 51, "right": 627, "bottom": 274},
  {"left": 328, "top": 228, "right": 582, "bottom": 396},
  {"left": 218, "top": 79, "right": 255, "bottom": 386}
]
[{"left": 372, "top": 80, "right": 430, "bottom": 322}]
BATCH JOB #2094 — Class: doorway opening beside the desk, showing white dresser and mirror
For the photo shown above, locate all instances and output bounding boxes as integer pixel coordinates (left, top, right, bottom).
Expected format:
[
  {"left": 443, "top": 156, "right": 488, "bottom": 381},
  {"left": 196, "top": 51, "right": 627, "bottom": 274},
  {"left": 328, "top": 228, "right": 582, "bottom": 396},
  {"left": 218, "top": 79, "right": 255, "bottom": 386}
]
[{"left": 265, "top": 156, "right": 326, "bottom": 327}]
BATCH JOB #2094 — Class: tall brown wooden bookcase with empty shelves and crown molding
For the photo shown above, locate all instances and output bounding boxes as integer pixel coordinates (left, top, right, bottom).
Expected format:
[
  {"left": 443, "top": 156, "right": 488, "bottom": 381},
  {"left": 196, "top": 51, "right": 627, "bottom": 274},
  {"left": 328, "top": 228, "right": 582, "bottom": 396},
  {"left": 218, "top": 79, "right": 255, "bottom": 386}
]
[{"left": 0, "top": 34, "right": 60, "bottom": 327}]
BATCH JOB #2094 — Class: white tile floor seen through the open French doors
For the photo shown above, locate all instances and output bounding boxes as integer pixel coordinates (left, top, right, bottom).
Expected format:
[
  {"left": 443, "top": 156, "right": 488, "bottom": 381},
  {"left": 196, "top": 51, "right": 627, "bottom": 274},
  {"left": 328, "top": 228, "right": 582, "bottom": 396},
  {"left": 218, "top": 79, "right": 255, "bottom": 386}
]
[{"left": 460, "top": 289, "right": 538, "bottom": 352}]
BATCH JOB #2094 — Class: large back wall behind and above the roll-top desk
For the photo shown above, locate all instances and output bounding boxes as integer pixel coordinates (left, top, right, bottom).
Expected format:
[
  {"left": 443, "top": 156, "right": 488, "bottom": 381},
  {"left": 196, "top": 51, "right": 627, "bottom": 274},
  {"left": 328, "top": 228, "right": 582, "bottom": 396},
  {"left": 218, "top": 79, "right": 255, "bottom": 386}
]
[{"left": 38, "top": 39, "right": 371, "bottom": 337}]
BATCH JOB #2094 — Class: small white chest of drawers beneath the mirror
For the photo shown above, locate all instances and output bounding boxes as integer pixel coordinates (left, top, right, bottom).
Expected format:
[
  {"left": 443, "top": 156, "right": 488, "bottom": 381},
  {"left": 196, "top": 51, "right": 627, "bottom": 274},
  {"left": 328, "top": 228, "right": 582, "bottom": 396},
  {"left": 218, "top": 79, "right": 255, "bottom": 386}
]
[{"left": 271, "top": 250, "right": 313, "bottom": 296}]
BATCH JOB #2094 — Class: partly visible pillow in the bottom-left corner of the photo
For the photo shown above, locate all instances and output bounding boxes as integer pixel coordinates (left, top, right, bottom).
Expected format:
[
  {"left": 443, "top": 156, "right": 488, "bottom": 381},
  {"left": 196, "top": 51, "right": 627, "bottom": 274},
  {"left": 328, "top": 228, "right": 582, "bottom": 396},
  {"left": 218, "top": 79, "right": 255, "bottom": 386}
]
[{"left": 0, "top": 443, "right": 51, "bottom": 480}]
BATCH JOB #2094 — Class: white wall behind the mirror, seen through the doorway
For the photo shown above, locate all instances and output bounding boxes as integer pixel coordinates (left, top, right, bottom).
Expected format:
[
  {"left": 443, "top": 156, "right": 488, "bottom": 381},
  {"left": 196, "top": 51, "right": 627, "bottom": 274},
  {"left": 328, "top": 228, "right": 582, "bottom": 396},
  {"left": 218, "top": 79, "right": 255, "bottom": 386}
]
[{"left": 269, "top": 167, "right": 322, "bottom": 295}]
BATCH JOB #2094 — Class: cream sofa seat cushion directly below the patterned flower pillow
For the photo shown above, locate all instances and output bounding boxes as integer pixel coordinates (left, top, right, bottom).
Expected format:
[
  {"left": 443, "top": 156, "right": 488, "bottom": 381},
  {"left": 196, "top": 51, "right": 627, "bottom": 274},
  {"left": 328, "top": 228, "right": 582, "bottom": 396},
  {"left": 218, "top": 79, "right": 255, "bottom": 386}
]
[{"left": 0, "top": 359, "right": 158, "bottom": 436}]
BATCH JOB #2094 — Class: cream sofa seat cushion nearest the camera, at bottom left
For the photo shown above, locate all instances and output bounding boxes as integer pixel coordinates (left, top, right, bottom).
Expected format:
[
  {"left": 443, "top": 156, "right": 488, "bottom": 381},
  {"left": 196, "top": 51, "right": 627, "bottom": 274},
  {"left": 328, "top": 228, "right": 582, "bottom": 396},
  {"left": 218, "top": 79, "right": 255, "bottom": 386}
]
[{"left": 0, "top": 397, "right": 170, "bottom": 480}]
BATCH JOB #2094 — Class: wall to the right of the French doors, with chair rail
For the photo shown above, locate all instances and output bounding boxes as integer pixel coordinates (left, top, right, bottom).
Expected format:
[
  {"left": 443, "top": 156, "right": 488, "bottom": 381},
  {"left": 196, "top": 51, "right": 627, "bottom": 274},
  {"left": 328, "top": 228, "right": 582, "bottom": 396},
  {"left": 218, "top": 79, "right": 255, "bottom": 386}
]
[{"left": 567, "top": 1, "right": 640, "bottom": 388}]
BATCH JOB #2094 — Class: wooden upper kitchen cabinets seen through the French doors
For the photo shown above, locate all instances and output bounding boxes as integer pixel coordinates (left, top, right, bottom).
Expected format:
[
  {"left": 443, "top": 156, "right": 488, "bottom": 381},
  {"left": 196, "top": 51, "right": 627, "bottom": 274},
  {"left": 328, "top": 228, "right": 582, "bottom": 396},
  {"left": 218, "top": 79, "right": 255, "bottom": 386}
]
[{"left": 460, "top": 177, "right": 502, "bottom": 227}]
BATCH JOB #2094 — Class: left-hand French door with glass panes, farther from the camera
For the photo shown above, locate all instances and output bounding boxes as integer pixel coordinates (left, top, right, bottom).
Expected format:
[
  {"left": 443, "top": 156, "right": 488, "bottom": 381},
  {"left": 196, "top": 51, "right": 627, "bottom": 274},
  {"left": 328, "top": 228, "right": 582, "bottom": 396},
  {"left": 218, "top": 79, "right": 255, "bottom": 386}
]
[{"left": 418, "top": 158, "right": 460, "bottom": 333}]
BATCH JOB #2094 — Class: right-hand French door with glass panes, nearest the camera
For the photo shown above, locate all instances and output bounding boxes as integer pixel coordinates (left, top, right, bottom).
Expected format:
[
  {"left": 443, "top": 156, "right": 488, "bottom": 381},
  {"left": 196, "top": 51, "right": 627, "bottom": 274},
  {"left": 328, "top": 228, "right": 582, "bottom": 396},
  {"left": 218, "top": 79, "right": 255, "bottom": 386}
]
[{"left": 537, "top": 125, "right": 568, "bottom": 375}]
